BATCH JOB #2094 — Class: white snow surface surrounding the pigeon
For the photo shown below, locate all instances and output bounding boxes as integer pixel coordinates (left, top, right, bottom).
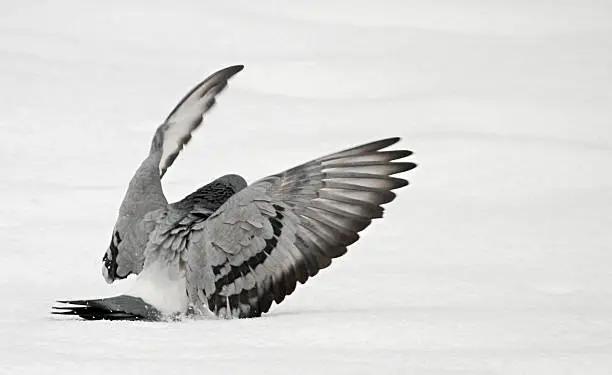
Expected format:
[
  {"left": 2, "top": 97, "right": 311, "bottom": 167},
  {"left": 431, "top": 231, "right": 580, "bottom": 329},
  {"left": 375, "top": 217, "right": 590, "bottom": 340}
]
[{"left": 0, "top": 0, "right": 612, "bottom": 375}]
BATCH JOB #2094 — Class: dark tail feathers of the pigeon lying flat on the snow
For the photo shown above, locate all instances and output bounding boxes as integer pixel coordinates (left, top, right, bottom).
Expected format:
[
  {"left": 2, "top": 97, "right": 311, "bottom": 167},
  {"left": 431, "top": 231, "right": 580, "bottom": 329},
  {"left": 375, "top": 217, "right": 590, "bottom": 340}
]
[{"left": 51, "top": 295, "right": 164, "bottom": 321}]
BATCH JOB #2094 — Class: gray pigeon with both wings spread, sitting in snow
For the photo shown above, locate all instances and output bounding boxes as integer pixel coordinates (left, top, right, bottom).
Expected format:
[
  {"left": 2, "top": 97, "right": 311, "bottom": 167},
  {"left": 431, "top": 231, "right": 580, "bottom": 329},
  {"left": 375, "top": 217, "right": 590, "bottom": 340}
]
[{"left": 53, "top": 65, "right": 416, "bottom": 320}]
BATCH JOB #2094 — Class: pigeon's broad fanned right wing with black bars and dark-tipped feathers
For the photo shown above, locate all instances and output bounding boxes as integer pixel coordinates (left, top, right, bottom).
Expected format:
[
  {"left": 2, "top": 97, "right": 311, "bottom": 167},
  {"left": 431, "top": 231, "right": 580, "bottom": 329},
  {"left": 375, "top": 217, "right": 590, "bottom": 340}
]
[{"left": 185, "top": 138, "right": 416, "bottom": 318}]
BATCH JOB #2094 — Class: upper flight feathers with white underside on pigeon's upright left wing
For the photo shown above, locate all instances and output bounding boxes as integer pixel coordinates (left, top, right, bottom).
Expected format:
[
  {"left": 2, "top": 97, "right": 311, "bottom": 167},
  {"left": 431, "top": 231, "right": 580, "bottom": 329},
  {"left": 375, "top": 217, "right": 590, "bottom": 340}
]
[{"left": 151, "top": 65, "right": 244, "bottom": 177}]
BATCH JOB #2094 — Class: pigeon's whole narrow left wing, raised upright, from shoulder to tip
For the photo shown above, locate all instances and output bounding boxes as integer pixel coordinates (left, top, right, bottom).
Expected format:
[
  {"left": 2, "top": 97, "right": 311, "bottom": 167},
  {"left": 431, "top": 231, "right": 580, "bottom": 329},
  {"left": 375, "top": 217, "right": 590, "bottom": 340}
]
[{"left": 102, "top": 65, "right": 243, "bottom": 283}]
